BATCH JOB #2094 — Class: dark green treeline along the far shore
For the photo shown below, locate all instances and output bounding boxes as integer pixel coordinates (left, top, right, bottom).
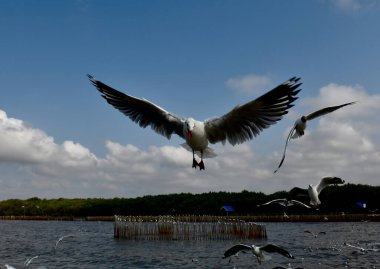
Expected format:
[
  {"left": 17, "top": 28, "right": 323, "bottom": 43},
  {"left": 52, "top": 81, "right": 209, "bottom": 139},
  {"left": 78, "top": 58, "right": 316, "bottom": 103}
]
[{"left": 0, "top": 184, "right": 380, "bottom": 217}]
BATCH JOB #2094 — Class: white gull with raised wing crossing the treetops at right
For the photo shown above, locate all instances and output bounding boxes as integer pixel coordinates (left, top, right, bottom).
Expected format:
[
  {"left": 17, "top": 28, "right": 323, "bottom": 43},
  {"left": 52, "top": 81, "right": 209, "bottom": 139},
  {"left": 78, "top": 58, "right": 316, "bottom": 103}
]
[{"left": 289, "top": 177, "right": 344, "bottom": 208}]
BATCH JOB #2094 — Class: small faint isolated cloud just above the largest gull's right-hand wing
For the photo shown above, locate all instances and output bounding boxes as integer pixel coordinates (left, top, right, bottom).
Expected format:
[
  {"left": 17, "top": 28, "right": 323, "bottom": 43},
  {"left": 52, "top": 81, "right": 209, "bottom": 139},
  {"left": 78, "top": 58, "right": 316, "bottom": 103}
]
[{"left": 226, "top": 74, "right": 271, "bottom": 93}]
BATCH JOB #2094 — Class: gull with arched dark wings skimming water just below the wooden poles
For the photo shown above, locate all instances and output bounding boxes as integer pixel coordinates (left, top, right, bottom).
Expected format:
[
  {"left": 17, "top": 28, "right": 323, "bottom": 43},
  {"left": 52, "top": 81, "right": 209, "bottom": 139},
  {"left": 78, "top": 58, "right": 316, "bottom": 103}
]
[{"left": 223, "top": 244, "right": 294, "bottom": 264}]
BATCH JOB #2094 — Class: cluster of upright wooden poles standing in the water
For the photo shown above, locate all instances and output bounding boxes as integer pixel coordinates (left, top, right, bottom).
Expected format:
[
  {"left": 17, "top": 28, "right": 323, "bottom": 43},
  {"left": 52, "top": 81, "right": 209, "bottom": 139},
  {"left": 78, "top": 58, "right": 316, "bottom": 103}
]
[{"left": 114, "top": 216, "right": 267, "bottom": 240}]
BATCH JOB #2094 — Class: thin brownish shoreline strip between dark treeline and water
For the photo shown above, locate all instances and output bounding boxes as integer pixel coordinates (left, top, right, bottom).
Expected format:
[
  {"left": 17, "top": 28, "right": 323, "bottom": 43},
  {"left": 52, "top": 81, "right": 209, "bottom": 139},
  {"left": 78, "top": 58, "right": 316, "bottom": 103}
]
[{"left": 0, "top": 214, "right": 380, "bottom": 222}]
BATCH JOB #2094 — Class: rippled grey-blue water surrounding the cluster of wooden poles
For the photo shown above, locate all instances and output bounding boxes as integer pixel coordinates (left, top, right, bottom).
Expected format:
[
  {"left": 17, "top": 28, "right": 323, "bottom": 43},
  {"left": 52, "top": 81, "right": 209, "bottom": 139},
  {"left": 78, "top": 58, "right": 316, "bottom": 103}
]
[{"left": 0, "top": 220, "right": 380, "bottom": 269}]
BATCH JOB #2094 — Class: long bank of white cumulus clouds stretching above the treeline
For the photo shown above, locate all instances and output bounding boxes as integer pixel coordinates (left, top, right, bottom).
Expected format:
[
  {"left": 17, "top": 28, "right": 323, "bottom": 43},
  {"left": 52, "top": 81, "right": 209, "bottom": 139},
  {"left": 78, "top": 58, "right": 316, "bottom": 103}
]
[{"left": 0, "top": 81, "right": 380, "bottom": 200}]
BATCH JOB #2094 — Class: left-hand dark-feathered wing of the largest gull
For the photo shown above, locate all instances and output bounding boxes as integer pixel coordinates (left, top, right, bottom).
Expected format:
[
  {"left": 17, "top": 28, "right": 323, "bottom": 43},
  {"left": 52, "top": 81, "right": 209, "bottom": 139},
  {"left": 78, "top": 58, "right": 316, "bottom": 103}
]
[{"left": 88, "top": 75, "right": 184, "bottom": 139}]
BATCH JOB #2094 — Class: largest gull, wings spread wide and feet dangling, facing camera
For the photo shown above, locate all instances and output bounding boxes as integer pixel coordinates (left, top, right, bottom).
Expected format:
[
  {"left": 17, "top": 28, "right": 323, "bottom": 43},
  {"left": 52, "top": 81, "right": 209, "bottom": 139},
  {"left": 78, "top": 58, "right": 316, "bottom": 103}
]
[{"left": 88, "top": 75, "right": 301, "bottom": 170}]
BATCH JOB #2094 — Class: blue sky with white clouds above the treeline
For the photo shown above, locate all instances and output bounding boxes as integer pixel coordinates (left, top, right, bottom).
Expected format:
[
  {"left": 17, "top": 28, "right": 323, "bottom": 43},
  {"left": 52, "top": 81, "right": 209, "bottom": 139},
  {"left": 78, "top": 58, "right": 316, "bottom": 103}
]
[{"left": 0, "top": 0, "right": 380, "bottom": 200}]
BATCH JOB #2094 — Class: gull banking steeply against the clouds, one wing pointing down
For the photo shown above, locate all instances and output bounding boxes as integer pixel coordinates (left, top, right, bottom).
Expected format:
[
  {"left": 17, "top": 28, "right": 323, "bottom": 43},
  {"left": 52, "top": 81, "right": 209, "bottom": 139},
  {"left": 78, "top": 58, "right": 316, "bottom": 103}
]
[{"left": 274, "top": 102, "right": 356, "bottom": 173}]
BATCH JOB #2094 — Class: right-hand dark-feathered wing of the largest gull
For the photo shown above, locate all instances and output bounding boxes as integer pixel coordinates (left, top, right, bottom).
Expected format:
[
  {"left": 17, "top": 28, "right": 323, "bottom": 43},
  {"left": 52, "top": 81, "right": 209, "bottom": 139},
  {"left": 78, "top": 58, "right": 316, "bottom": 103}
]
[{"left": 205, "top": 77, "right": 301, "bottom": 145}]
